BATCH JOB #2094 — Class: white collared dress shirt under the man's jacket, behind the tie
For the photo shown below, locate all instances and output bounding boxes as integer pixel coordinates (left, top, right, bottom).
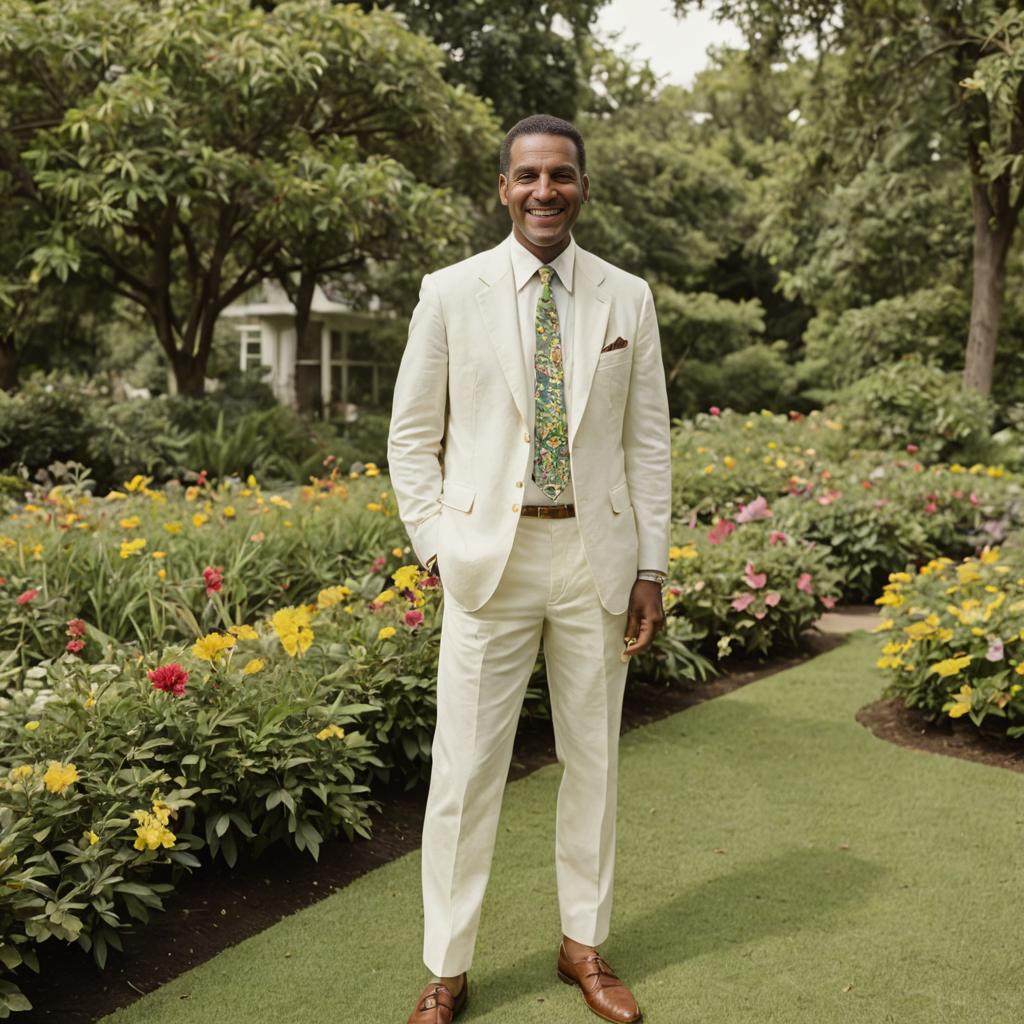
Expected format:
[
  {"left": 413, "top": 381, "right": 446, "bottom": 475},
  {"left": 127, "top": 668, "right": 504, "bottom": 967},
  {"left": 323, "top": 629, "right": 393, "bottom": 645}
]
[{"left": 510, "top": 234, "right": 575, "bottom": 505}]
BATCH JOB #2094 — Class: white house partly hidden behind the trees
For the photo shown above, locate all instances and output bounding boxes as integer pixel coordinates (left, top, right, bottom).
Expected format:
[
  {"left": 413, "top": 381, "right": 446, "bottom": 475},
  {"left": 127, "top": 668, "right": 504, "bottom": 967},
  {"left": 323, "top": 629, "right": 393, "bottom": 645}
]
[{"left": 221, "top": 281, "right": 393, "bottom": 420}]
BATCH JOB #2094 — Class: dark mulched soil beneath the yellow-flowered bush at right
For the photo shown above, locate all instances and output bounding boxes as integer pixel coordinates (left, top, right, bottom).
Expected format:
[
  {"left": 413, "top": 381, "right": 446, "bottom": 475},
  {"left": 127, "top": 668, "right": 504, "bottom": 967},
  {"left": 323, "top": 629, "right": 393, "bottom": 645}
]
[{"left": 857, "top": 697, "right": 1024, "bottom": 772}]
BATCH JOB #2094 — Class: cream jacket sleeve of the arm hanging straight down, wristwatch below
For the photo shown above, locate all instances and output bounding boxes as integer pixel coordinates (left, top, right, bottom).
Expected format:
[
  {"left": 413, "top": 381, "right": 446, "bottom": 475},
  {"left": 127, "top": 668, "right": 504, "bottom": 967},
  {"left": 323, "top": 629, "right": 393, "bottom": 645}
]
[{"left": 623, "top": 284, "right": 672, "bottom": 572}]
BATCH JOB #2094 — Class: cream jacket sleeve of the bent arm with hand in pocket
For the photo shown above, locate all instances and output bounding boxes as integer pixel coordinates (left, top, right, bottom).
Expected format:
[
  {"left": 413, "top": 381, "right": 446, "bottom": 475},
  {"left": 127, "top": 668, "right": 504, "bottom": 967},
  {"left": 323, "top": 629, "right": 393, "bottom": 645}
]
[{"left": 387, "top": 273, "right": 447, "bottom": 565}]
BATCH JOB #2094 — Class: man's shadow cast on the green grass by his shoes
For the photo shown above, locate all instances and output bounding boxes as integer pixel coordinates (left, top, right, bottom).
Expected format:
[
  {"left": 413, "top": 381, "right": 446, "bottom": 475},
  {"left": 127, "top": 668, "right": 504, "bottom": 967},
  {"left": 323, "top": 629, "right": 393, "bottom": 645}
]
[{"left": 473, "top": 849, "right": 885, "bottom": 1009}]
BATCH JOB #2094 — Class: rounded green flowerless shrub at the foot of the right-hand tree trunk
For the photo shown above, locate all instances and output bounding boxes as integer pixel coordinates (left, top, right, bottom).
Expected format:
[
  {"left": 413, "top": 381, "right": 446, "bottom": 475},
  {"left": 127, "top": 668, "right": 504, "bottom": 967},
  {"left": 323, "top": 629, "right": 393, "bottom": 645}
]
[{"left": 826, "top": 356, "right": 994, "bottom": 462}]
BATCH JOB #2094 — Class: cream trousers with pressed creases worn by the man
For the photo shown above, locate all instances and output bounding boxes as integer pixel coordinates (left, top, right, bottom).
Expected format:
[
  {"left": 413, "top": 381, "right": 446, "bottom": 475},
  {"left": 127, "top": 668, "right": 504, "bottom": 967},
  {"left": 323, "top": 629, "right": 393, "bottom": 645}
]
[{"left": 423, "top": 517, "right": 628, "bottom": 977}]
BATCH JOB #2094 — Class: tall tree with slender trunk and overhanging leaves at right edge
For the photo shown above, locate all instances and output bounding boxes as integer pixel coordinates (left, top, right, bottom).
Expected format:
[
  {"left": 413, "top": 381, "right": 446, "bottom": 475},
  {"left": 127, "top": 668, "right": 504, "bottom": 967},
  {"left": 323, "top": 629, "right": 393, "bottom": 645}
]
[{"left": 676, "top": 0, "right": 1024, "bottom": 393}]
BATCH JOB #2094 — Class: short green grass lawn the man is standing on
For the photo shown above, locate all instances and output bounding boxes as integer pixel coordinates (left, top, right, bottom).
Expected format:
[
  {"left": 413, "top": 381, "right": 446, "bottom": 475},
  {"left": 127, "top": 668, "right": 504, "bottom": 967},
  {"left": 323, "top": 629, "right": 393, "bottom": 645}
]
[{"left": 105, "top": 635, "right": 1024, "bottom": 1024}]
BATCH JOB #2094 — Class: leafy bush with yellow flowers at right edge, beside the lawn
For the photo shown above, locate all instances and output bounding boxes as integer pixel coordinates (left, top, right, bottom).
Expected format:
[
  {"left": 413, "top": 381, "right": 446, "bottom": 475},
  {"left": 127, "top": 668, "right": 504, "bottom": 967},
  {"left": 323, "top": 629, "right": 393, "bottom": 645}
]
[{"left": 876, "top": 548, "right": 1024, "bottom": 736}]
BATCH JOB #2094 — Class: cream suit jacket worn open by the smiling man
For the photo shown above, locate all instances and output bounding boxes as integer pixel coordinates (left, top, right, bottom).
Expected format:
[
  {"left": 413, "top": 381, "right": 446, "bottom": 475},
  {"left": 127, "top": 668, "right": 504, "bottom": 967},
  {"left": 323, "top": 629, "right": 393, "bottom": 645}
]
[{"left": 388, "top": 239, "right": 672, "bottom": 613}]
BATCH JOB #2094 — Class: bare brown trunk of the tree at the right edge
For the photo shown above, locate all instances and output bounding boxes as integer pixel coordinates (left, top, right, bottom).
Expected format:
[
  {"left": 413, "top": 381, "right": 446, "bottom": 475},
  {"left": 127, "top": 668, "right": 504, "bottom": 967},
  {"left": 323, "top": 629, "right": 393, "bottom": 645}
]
[{"left": 964, "top": 181, "right": 1016, "bottom": 394}]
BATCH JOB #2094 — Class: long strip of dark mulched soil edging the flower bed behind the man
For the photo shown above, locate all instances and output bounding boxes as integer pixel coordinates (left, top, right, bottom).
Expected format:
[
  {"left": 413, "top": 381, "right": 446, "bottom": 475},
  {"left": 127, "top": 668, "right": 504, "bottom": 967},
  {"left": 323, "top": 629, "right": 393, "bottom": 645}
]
[{"left": 8, "top": 633, "right": 958, "bottom": 1024}]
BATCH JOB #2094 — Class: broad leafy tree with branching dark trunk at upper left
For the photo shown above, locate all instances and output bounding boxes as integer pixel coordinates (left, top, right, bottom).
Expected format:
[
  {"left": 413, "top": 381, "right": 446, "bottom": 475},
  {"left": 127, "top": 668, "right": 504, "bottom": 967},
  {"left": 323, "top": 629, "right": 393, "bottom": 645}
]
[{"left": 0, "top": 0, "right": 497, "bottom": 394}]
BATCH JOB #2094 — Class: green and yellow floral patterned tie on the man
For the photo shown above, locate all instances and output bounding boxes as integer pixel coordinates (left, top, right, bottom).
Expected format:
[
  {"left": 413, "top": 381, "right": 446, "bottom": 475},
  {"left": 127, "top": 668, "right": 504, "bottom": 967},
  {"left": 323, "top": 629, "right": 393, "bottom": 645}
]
[{"left": 534, "top": 266, "right": 569, "bottom": 501}]
